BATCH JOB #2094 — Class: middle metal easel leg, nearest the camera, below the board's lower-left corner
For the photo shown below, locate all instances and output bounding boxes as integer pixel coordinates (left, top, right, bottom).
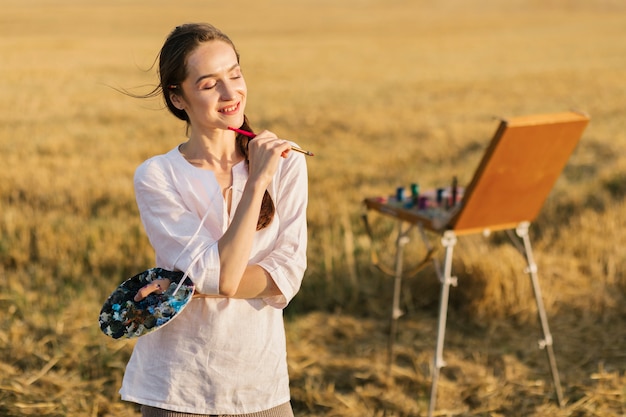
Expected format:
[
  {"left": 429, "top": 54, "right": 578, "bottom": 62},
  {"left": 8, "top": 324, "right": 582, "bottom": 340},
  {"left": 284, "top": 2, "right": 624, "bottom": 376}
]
[{"left": 428, "top": 230, "right": 457, "bottom": 417}]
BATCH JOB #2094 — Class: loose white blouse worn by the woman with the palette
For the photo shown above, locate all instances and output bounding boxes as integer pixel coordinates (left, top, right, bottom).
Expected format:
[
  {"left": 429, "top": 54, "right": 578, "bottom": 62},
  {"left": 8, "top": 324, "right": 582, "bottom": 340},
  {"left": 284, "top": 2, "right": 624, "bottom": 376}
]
[{"left": 120, "top": 144, "right": 308, "bottom": 414}]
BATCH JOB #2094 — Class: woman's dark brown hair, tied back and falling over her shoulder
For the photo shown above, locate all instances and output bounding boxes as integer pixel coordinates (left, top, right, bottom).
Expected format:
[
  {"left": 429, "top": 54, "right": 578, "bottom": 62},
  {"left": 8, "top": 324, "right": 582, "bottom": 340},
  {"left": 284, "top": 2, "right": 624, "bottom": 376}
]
[{"left": 149, "top": 23, "right": 275, "bottom": 230}]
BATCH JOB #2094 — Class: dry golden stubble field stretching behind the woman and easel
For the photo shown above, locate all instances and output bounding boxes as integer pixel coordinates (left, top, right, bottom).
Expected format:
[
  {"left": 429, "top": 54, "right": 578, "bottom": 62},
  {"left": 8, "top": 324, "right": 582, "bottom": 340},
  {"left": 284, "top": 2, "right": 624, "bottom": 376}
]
[{"left": 0, "top": 0, "right": 626, "bottom": 417}]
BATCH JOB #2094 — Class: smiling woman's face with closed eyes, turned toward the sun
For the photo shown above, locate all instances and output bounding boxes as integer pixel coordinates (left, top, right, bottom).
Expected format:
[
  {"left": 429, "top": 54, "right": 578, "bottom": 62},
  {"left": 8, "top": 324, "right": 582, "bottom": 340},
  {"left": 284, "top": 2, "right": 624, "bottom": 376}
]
[{"left": 171, "top": 40, "right": 247, "bottom": 130}]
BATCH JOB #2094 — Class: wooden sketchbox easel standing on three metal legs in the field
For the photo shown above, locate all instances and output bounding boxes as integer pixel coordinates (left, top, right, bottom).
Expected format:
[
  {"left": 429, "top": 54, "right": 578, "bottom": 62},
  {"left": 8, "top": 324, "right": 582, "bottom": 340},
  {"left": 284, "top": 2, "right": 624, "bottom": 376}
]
[{"left": 364, "top": 112, "right": 589, "bottom": 417}]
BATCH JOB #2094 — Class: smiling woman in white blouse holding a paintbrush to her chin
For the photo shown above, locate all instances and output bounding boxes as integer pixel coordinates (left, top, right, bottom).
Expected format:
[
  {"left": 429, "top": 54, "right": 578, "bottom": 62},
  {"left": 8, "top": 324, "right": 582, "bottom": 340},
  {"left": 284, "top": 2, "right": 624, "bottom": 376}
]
[{"left": 120, "top": 24, "right": 308, "bottom": 417}]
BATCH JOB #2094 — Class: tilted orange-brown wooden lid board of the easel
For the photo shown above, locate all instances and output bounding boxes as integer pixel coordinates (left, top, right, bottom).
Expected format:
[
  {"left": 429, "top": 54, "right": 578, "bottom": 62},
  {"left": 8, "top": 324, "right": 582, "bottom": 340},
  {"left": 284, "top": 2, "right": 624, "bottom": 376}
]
[{"left": 448, "top": 112, "right": 589, "bottom": 234}]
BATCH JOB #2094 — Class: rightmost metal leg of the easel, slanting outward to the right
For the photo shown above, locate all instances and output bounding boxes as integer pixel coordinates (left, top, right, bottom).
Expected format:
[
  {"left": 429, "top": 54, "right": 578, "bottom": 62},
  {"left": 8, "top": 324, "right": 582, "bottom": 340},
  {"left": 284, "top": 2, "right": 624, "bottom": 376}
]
[{"left": 515, "top": 222, "right": 563, "bottom": 407}]
